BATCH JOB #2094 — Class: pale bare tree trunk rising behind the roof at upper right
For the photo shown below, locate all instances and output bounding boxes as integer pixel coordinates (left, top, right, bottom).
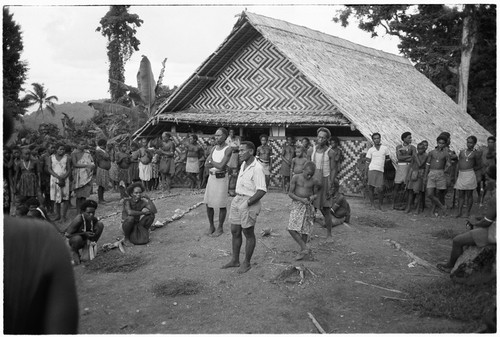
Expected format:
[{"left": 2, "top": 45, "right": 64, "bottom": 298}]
[{"left": 457, "top": 16, "right": 476, "bottom": 112}]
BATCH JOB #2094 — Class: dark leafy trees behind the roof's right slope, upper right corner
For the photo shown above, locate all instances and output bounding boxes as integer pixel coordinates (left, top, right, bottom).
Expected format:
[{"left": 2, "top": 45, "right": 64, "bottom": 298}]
[{"left": 333, "top": 5, "right": 496, "bottom": 131}]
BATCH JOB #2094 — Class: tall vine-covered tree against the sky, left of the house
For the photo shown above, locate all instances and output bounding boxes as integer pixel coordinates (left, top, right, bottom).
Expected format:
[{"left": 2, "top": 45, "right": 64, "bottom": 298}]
[{"left": 96, "top": 5, "right": 143, "bottom": 102}]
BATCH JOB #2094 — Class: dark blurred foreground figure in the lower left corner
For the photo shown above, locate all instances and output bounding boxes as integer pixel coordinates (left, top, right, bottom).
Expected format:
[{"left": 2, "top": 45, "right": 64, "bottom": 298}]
[{"left": 3, "top": 216, "right": 78, "bottom": 334}]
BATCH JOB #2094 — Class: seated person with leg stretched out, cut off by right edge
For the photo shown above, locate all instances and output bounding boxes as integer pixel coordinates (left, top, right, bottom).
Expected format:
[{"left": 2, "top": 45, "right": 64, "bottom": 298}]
[{"left": 437, "top": 165, "right": 497, "bottom": 273}]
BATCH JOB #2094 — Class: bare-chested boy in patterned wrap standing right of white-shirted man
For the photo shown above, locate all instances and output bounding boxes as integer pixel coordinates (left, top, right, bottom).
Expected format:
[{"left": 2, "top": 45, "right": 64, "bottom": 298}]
[{"left": 287, "top": 161, "right": 322, "bottom": 260}]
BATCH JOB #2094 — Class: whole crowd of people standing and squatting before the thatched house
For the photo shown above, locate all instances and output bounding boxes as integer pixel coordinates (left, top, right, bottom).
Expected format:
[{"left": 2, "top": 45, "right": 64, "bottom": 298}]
[{"left": 4, "top": 107, "right": 496, "bottom": 331}]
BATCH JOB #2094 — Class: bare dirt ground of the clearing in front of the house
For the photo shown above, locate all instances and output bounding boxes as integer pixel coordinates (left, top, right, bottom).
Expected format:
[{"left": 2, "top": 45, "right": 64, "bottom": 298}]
[{"left": 61, "top": 189, "right": 488, "bottom": 334}]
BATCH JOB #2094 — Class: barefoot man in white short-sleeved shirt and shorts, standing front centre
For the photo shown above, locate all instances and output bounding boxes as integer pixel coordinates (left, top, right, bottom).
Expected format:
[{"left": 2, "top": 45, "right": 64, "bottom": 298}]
[{"left": 222, "top": 141, "right": 267, "bottom": 274}]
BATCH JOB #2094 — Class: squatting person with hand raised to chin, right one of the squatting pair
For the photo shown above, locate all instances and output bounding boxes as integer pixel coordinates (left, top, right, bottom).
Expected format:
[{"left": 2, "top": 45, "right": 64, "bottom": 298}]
[{"left": 122, "top": 182, "right": 157, "bottom": 245}]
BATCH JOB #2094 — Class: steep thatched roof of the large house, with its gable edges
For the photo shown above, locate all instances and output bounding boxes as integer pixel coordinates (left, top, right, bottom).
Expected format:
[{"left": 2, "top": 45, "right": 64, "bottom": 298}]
[{"left": 138, "top": 12, "right": 490, "bottom": 148}]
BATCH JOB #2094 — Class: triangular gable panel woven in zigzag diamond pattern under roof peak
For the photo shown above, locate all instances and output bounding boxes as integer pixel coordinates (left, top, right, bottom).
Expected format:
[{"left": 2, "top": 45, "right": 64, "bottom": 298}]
[{"left": 190, "top": 37, "right": 335, "bottom": 113}]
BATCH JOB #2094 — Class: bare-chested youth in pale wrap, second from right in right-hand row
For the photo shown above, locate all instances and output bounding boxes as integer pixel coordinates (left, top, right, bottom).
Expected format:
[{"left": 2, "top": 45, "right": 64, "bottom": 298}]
[{"left": 455, "top": 136, "right": 482, "bottom": 218}]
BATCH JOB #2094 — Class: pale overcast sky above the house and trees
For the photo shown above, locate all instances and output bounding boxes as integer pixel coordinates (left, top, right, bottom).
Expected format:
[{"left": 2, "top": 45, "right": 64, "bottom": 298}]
[{"left": 9, "top": 0, "right": 399, "bottom": 110}]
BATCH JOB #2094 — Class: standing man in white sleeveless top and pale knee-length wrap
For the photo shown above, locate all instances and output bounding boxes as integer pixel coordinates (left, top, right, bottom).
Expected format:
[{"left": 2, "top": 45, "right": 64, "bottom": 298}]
[{"left": 203, "top": 128, "right": 231, "bottom": 237}]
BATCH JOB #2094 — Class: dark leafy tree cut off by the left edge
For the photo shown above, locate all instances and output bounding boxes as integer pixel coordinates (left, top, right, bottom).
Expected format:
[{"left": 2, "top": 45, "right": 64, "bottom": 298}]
[{"left": 2, "top": 6, "right": 28, "bottom": 119}]
